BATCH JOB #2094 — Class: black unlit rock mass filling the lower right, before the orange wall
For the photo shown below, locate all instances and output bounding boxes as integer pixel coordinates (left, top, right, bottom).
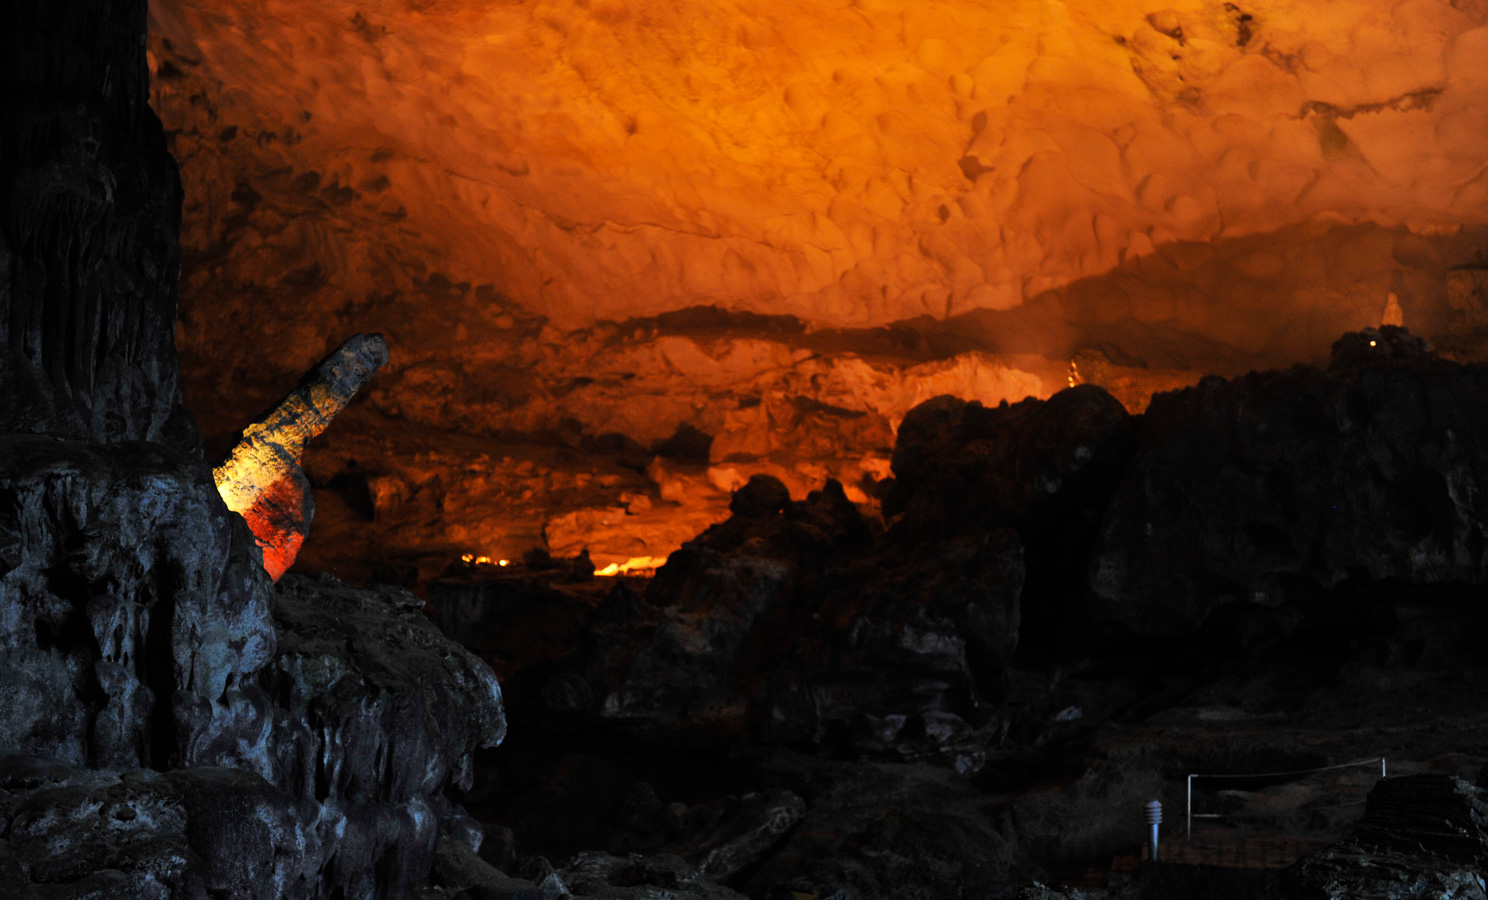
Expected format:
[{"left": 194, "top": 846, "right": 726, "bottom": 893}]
[{"left": 434, "top": 329, "right": 1488, "bottom": 900}]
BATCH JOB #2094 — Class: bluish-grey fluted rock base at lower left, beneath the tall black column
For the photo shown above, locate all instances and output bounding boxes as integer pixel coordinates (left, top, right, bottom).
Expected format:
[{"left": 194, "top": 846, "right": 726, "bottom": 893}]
[{"left": 0, "top": 508, "right": 508, "bottom": 899}]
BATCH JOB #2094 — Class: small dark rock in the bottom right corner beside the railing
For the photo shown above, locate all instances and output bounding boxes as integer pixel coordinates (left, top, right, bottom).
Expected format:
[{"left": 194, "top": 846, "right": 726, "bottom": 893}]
[{"left": 1283, "top": 775, "right": 1488, "bottom": 900}]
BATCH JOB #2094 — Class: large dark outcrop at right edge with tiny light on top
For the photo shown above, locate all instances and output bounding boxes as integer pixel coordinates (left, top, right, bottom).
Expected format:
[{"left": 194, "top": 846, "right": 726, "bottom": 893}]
[{"left": 1089, "top": 327, "right": 1488, "bottom": 634}]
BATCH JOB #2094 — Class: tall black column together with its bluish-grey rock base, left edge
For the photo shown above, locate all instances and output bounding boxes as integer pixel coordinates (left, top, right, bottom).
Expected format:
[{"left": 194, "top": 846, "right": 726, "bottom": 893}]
[{"left": 0, "top": 0, "right": 514, "bottom": 900}]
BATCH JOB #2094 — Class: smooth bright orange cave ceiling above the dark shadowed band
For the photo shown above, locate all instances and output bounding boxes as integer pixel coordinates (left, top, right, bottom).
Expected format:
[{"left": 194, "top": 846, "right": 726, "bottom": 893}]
[{"left": 152, "top": 0, "right": 1488, "bottom": 327}]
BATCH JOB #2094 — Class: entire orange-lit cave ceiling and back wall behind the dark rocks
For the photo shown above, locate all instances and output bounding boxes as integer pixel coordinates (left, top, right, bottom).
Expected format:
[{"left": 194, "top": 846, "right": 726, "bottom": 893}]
[{"left": 152, "top": 0, "right": 1488, "bottom": 574}]
